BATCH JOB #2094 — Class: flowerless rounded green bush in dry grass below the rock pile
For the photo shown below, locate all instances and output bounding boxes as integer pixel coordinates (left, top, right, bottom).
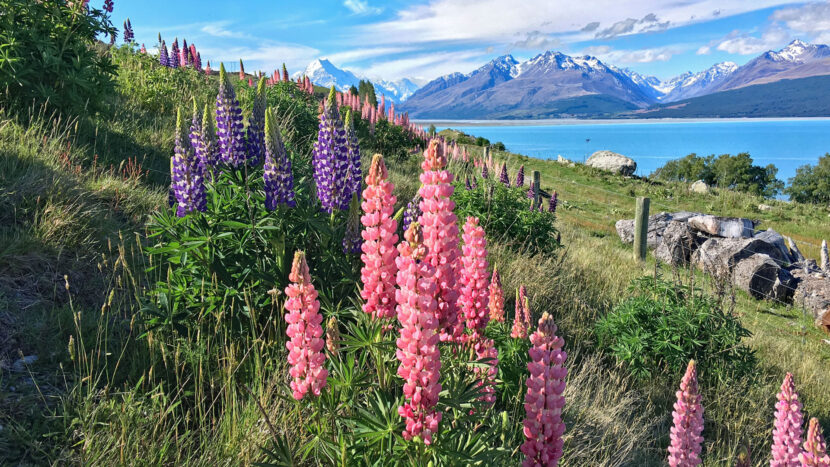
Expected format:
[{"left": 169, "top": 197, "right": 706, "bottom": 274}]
[{"left": 596, "top": 276, "right": 755, "bottom": 379}]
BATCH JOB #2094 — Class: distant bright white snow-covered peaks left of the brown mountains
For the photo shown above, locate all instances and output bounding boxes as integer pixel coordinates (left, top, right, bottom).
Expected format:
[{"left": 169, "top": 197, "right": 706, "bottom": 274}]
[{"left": 293, "top": 58, "right": 419, "bottom": 102}]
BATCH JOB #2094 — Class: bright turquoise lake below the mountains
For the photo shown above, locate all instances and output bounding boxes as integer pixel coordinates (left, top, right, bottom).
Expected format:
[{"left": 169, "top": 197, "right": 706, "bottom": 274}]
[{"left": 426, "top": 119, "right": 830, "bottom": 182}]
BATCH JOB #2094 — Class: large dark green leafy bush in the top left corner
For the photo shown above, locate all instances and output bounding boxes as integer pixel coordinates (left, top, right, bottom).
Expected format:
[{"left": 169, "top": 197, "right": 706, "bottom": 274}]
[{"left": 0, "top": 0, "right": 115, "bottom": 113}]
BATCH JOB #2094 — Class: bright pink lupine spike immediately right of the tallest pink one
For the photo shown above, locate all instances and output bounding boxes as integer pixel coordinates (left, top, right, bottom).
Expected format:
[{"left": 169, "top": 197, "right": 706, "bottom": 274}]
[{"left": 458, "top": 217, "right": 490, "bottom": 340}]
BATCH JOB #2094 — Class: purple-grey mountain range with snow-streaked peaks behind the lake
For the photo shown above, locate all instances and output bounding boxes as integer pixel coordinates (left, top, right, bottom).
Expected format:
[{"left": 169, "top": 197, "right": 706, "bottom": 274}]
[{"left": 402, "top": 40, "right": 830, "bottom": 119}]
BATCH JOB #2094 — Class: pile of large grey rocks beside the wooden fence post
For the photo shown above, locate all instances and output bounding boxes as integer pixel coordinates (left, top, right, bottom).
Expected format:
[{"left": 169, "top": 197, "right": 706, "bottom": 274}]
[{"left": 616, "top": 212, "right": 830, "bottom": 331}]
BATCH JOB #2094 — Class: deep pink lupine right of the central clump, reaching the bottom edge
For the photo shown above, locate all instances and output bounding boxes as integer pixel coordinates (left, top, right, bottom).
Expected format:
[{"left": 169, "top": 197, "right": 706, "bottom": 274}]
[{"left": 521, "top": 312, "right": 568, "bottom": 467}]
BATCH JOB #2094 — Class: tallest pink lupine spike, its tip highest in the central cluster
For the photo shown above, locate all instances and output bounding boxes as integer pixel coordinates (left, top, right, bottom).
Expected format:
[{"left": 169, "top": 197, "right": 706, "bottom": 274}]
[{"left": 418, "top": 139, "right": 464, "bottom": 341}]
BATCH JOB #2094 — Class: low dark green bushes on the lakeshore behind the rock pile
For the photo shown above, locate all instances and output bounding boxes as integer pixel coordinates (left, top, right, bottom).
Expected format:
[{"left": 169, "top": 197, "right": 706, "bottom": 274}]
[{"left": 651, "top": 152, "right": 784, "bottom": 198}]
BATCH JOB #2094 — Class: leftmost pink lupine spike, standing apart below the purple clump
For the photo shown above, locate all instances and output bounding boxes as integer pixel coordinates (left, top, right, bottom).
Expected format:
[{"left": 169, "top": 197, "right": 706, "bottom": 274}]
[{"left": 285, "top": 251, "right": 328, "bottom": 400}]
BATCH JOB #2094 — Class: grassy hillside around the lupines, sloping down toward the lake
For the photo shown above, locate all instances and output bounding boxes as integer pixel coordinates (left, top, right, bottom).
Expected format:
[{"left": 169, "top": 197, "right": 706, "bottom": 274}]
[{"left": 0, "top": 44, "right": 830, "bottom": 465}]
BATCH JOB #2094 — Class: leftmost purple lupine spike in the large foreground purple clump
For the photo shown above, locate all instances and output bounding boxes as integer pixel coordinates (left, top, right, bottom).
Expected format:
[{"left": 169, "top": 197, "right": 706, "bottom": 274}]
[{"left": 170, "top": 109, "right": 207, "bottom": 217}]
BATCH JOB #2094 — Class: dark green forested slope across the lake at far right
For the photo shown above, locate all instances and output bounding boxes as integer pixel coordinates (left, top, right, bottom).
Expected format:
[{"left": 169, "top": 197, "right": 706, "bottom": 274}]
[{"left": 624, "top": 76, "right": 830, "bottom": 118}]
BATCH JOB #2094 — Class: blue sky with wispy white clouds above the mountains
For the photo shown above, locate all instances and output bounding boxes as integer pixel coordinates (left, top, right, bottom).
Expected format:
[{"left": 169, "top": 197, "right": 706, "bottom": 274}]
[{"left": 114, "top": 0, "right": 830, "bottom": 83}]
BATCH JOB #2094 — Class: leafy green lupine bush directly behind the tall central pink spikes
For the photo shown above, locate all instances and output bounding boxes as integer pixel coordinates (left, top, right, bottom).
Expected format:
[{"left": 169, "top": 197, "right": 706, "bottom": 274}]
[{"left": 452, "top": 178, "right": 561, "bottom": 254}]
